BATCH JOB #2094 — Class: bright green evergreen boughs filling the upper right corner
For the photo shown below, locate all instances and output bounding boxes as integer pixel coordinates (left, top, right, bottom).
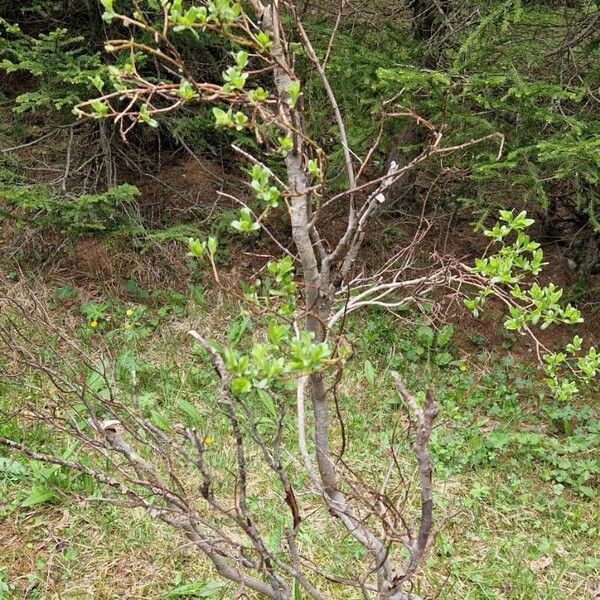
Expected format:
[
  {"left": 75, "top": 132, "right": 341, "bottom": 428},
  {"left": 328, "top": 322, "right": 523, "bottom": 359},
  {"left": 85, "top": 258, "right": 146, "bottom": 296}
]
[{"left": 378, "top": 0, "right": 600, "bottom": 233}]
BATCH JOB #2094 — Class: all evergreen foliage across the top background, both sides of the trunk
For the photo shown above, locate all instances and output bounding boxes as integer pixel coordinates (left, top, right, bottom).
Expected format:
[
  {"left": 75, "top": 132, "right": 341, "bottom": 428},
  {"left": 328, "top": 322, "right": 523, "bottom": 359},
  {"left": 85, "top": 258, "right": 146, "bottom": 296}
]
[{"left": 0, "top": 0, "right": 600, "bottom": 247}]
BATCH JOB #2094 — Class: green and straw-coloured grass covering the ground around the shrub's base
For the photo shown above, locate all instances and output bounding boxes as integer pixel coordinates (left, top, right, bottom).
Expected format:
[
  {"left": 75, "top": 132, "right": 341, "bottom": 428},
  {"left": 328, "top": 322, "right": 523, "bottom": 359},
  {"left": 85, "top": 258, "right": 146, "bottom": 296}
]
[{"left": 0, "top": 288, "right": 600, "bottom": 600}]
